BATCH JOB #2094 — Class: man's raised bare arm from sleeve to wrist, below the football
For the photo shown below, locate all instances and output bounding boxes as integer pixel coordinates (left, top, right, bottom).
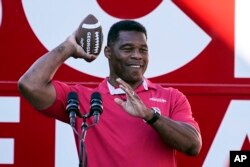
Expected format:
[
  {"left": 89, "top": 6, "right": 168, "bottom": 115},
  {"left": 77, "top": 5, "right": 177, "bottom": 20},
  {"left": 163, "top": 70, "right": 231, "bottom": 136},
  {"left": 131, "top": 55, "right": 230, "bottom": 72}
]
[{"left": 18, "top": 42, "right": 74, "bottom": 109}]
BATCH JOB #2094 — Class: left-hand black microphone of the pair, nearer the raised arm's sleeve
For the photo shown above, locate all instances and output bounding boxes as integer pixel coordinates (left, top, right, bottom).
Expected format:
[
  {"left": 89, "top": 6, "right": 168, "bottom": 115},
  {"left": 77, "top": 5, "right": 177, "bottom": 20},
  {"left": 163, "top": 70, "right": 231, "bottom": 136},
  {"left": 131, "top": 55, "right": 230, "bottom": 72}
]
[{"left": 66, "top": 92, "right": 80, "bottom": 127}]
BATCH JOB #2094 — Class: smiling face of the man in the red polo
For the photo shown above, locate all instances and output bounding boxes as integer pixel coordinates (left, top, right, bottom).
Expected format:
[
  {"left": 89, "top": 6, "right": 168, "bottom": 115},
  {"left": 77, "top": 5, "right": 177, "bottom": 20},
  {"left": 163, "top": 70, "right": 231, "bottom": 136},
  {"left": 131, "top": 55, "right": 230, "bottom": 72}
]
[{"left": 106, "top": 31, "right": 148, "bottom": 84}]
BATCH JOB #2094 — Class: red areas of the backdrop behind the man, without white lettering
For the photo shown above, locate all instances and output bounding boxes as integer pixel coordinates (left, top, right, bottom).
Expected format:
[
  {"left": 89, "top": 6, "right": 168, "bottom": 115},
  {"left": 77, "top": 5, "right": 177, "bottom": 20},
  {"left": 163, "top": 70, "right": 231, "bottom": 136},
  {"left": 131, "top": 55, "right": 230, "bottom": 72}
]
[{"left": 0, "top": 0, "right": 250, "bottom": 167}]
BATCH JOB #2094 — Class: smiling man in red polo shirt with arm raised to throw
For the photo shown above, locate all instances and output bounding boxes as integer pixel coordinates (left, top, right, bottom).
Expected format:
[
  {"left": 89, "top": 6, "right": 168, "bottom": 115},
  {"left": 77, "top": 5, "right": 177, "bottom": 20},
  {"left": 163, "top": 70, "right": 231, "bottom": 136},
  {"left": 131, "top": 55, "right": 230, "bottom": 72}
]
[{"left": 19, "top": 20, "right": 202, "bottom": 167}]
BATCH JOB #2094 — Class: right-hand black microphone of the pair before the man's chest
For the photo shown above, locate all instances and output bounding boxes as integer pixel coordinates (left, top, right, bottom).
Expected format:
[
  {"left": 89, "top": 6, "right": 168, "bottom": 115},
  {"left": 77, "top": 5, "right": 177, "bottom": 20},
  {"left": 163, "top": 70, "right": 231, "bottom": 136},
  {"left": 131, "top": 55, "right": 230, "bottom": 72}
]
[{"left": 90, "top": 92, "right": 103, "bottom": 123}]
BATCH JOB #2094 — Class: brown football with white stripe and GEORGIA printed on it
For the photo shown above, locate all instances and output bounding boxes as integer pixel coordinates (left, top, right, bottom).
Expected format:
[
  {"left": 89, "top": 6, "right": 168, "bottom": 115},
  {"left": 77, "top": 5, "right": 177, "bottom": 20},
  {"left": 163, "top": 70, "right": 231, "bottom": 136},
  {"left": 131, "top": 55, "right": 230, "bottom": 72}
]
[{"left": 76, "top": 14, "right": 103, "bottom": 55}]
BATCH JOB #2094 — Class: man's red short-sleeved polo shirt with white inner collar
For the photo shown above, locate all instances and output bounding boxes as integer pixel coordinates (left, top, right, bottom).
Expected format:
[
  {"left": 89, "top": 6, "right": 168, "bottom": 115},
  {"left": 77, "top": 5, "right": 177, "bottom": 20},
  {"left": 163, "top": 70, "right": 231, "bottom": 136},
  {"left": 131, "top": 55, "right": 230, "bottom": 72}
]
[{"left": 42, "top": 79, "right": 199, "bottom": 167}]
